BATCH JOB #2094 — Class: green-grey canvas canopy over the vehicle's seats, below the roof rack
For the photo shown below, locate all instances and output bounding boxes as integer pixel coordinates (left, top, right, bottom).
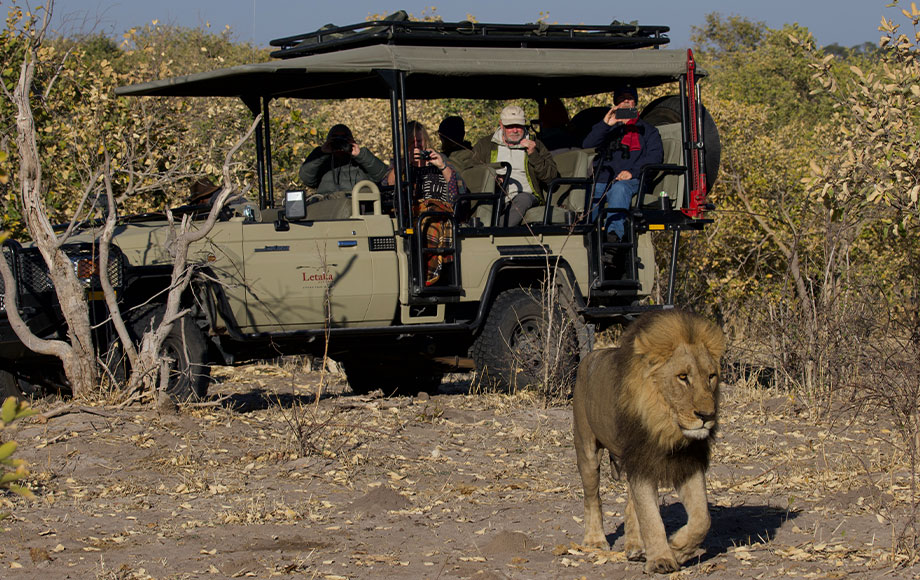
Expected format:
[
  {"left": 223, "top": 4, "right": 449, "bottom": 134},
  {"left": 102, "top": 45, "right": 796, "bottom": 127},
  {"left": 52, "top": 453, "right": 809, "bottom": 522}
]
[{"left": 115, "top": 44, "right": 700, "bottom": 100}]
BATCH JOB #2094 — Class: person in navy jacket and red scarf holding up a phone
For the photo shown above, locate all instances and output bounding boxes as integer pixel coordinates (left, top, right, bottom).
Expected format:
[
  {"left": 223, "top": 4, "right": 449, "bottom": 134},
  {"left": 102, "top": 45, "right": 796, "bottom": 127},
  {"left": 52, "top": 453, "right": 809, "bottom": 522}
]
[{"left": 582, "top": 86, "right": 664, "bottom": 242}]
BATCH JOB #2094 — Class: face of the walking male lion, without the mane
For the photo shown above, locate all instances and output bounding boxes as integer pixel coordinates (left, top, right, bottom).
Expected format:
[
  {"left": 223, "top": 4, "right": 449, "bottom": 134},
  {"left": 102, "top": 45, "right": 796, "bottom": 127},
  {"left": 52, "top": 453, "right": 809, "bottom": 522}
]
[{"left": 655, "top": 344, "right": 719, "bottom": 439}]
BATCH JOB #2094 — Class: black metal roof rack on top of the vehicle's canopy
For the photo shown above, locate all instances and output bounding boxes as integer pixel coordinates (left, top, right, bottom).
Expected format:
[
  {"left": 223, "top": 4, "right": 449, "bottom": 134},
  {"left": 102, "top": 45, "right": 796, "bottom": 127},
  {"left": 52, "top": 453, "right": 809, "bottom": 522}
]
[{"left": 269, "top": 11, "right": 670, "bottom": 58}]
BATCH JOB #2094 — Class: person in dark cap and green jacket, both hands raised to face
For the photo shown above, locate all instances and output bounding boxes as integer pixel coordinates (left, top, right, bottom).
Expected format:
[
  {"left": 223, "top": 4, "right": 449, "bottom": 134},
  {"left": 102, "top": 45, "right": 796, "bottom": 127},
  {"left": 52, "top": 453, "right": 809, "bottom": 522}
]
[{"left": 300, "top": 124, "right": 387, "bottom": 194}]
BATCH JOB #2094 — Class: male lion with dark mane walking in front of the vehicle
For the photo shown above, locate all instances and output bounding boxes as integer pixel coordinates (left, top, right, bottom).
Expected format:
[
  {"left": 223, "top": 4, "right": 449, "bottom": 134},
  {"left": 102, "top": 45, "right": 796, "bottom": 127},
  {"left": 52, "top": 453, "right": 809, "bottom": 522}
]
[{"left": 573, "top": 310, "right": 725, "bottom": 573}]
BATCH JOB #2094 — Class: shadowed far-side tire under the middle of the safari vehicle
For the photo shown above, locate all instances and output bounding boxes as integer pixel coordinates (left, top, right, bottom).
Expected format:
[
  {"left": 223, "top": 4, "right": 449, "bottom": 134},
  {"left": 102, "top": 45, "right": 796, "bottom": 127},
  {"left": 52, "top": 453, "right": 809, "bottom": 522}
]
[{"left": 340, "top": 358, "right": 444, "bottom": 396}]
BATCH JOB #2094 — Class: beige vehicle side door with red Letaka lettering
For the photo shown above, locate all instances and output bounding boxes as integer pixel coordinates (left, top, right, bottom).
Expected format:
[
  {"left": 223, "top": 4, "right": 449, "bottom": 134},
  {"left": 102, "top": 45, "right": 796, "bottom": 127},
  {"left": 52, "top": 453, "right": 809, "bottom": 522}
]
[{"left": 238, "top": 200, "right": 398, "bottom": 332}]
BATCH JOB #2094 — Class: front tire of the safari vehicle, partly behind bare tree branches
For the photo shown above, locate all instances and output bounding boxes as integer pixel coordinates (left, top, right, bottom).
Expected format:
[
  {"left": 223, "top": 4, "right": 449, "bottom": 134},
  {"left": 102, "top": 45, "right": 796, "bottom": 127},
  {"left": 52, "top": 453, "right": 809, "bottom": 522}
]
[{"left": 131, "top": 307, "right": 211, "bottom": 403}]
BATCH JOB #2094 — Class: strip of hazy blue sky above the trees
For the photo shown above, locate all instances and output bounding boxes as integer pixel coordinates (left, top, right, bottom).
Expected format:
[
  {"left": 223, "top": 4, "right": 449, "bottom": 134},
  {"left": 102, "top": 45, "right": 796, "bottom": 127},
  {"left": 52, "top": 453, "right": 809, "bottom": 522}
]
[{"left": 48, "top": 0, "right": 909, "bottom": 48}]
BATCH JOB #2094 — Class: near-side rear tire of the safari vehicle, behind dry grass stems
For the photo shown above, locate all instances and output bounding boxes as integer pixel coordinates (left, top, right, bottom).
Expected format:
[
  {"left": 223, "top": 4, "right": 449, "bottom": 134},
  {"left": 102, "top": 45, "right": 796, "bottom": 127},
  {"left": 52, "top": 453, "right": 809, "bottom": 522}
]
[{"left": 471, "top": 288, "right": 583, "bottom": 396}]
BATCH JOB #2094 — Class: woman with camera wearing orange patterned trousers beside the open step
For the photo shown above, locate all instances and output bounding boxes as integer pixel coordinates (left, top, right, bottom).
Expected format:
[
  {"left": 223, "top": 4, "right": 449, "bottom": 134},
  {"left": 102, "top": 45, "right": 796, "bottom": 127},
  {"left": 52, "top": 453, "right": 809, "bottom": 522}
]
[{"left": 387, "top": 121, "right": 463, "bottom": 286}]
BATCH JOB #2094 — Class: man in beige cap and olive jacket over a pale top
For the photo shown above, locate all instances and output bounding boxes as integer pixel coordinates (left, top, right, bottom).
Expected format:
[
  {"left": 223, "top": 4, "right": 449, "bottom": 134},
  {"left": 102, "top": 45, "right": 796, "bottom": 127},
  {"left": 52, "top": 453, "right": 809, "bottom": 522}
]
[{"left": 471, "top": 105, "right": 559, "bottom": 226}]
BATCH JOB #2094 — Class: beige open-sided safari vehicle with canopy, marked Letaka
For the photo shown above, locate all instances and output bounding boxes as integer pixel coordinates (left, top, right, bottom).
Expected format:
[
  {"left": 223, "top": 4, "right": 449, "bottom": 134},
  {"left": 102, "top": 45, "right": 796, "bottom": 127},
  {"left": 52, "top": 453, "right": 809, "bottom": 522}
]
[{"left": 0, "top": 19, "right": 719, "bottom": 398}]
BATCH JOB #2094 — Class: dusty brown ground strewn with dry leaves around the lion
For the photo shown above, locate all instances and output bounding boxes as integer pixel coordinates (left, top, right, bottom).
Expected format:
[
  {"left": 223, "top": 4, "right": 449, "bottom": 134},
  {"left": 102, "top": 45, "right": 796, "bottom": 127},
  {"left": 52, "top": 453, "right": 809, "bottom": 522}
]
[{"left": 0, "top": 365, "right": 920, "bottom": 579}]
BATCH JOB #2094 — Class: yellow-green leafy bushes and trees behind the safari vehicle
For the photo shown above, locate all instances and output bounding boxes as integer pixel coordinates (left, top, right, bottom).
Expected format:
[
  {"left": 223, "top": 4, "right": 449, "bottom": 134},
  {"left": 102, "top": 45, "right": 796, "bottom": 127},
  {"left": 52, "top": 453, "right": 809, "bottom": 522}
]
[{"left": 0, "top": 4, "right": 920, "bottom": 568}]
